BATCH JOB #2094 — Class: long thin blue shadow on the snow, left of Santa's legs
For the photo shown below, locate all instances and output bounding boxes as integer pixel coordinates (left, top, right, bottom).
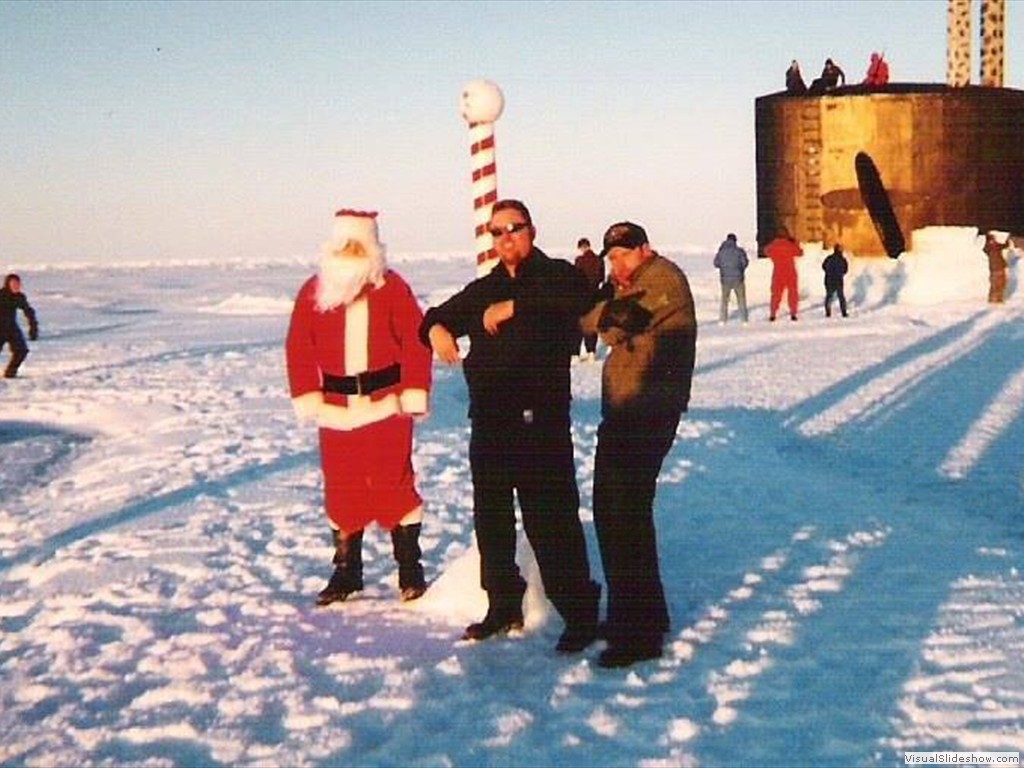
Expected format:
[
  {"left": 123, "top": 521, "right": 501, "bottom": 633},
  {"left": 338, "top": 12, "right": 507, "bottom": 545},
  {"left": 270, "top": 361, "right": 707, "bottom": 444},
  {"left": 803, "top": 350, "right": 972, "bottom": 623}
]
[{"left": 0, "top": 451, "right": 318, "bottom": 572}]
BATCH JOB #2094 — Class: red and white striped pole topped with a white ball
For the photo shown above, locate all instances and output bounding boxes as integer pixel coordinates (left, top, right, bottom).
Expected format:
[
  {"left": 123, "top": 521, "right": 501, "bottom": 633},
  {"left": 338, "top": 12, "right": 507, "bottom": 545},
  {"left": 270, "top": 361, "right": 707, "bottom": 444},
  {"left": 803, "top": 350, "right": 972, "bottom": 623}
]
[{"left": 460, "top": 80, "right": 505, "bottom": 275}]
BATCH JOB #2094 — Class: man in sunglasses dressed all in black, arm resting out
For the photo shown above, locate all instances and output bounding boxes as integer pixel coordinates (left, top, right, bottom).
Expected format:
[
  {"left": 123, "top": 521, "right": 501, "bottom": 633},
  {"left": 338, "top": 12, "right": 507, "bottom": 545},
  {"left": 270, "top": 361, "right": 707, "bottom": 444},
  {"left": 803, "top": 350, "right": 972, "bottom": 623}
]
[{"left": 420, "top": 200, "right": 601, "bottom": 652}]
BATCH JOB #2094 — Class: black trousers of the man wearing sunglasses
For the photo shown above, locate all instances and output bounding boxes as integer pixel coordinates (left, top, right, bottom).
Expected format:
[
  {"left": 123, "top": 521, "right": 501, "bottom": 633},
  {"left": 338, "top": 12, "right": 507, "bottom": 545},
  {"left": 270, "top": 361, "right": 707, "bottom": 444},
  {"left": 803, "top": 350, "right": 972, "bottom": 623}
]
[{"left": 469, "top": 414, "right": 596, "bottom": 624}]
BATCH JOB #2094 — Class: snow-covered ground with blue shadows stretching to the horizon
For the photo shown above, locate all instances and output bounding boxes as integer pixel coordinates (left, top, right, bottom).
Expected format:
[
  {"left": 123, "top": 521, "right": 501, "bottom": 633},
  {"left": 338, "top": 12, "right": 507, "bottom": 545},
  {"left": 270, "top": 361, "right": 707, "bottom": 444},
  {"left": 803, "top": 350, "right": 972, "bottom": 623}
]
[{"left": 0, "top": 230, "right": 1024, "bottom": 766}]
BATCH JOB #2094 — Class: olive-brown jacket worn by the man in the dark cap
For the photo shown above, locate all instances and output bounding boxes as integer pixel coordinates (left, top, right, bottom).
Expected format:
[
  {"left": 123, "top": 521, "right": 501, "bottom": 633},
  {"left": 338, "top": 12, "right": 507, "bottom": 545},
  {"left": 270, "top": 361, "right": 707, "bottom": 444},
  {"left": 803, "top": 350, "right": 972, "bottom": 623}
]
[{"left": 580, "top": 254, "right": 697, "bottom": 418}]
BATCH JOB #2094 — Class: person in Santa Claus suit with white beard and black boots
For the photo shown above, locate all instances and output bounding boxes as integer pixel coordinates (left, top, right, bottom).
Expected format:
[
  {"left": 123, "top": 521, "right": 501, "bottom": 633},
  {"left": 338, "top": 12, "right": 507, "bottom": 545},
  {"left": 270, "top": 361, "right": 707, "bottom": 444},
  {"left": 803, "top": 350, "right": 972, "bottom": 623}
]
[{"left": 286, "top": 209, "right": 431, "bottom": 605}]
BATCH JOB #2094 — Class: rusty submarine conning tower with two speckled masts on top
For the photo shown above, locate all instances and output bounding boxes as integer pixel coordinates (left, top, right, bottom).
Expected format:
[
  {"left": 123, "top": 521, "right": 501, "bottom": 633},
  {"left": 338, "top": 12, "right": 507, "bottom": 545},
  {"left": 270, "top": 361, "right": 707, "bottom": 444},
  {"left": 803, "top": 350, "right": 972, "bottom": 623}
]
[{"left": 755, "top": 0, "right": 1024, "bottom": 258}]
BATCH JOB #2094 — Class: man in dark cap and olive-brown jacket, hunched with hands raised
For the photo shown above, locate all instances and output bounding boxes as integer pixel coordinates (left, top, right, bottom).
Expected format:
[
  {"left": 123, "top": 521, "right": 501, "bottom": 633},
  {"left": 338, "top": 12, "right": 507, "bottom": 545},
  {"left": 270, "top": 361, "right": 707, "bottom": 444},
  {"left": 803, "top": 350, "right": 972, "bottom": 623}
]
[{"left": 582, "top": 221, "right": 697, "bottom": 667}]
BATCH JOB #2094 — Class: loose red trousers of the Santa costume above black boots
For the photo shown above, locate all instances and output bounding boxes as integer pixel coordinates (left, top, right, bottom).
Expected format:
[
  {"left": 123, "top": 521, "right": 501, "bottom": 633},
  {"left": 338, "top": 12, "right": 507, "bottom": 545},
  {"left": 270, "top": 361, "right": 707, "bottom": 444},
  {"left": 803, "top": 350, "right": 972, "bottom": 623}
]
[{"left": 319, "top": 416, "right": 423, "bottom": 534}]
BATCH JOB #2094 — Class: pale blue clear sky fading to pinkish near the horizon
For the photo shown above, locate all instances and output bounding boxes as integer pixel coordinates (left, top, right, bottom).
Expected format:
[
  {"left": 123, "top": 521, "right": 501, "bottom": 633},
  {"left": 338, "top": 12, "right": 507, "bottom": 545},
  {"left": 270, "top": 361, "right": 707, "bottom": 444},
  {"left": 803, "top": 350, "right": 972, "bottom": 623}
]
[{"left": 0, "top": 0, "right": 1024, "bottom": 262}]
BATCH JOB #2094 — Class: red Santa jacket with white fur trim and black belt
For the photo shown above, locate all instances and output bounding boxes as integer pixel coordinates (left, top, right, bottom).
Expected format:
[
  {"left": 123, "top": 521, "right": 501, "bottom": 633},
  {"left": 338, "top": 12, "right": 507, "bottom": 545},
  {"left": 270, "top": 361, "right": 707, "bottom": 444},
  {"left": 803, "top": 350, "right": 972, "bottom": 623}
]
[{"left": 285, "top": 270, "right": 431, "bottom": 430}]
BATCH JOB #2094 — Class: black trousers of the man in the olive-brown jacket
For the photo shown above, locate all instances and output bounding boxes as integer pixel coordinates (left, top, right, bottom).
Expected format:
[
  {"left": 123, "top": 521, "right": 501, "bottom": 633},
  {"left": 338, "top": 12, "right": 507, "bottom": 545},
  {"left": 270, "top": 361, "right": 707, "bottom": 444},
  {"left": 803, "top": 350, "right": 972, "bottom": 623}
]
[{"left": 594, "top": 414, "right": 679, "bottom": 645}]
